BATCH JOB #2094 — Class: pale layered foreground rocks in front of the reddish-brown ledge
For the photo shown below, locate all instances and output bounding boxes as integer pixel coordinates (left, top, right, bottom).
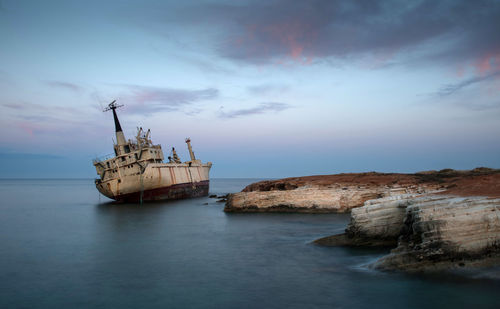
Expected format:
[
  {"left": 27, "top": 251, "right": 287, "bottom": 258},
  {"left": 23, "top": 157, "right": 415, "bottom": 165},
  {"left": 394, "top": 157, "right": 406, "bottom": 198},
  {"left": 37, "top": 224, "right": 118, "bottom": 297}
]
[{"left": 315, "top": 194, "right": 500, "bottom": 272}]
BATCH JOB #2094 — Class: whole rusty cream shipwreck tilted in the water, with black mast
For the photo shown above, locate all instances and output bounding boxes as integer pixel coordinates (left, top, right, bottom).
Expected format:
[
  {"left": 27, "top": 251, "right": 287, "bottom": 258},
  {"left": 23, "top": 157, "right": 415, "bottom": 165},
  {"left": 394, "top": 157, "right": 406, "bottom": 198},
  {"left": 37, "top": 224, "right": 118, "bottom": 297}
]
[{"left": 94, "top": 101, "right": 212, "bottom": 202}]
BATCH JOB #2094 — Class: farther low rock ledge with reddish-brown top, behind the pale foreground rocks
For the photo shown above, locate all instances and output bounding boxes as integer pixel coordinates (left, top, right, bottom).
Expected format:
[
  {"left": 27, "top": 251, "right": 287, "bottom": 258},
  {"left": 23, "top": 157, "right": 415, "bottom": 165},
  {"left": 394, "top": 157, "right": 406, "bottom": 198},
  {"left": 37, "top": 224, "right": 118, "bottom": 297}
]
[{"left": 224, "top": 168, "right": 500, "bottom": 213}]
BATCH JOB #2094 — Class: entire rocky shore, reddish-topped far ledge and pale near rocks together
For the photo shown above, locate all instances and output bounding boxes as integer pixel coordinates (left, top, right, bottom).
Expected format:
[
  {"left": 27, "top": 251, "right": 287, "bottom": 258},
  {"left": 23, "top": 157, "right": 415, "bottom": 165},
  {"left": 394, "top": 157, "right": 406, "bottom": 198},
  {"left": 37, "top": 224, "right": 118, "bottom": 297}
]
[{"left": 224, "top": 168, "right": 500, "bottom": 271}]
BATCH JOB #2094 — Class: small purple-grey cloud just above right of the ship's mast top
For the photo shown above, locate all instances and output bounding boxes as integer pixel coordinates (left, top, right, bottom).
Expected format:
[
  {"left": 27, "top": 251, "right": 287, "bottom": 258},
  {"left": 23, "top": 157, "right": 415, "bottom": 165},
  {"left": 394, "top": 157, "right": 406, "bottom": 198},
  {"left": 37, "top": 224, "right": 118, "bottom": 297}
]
[{"left": 119, "top": 85, "right": 219, "bottom": 114}]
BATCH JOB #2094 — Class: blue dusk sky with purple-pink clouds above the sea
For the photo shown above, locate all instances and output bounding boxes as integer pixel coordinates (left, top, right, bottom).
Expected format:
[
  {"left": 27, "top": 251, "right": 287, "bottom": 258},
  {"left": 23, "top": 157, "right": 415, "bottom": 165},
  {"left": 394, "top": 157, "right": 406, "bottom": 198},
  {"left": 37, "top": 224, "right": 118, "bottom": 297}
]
[{"left": 0, "top": 0, "right": 500, "bottom": 178}]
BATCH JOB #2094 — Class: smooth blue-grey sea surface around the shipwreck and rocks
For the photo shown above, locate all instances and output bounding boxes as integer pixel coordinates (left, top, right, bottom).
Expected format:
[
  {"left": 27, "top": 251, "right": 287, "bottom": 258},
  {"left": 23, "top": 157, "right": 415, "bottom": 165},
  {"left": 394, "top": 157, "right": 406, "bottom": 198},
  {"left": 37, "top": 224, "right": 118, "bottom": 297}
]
[{"left": 0, "top": 179, "right": 500, "bottom": 308}]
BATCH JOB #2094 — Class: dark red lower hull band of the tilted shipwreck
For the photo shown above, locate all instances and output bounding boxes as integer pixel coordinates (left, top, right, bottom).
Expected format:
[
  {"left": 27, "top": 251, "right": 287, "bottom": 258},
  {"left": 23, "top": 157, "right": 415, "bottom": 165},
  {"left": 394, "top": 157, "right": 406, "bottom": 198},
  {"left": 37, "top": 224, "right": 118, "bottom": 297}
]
[{"left": 113, "top": 180, "right": 209, "bottom": 203}]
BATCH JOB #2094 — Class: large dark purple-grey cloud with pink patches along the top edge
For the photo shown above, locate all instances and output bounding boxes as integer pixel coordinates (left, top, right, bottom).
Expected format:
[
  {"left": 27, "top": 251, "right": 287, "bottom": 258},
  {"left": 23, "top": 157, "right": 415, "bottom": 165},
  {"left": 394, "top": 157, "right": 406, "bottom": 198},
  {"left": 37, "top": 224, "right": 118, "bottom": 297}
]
[{"left": 150, "top": 0, "right": 500, "bottom": 70}]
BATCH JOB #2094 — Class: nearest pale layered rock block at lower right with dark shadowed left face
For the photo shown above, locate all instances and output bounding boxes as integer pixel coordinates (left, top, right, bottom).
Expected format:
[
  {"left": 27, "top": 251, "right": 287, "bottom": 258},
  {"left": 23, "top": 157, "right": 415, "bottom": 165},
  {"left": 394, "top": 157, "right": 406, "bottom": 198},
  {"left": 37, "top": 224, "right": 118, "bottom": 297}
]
[{"left": 373, "top": 196, "right": 500, "bottom": 271}]
